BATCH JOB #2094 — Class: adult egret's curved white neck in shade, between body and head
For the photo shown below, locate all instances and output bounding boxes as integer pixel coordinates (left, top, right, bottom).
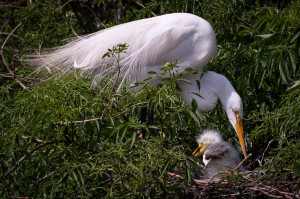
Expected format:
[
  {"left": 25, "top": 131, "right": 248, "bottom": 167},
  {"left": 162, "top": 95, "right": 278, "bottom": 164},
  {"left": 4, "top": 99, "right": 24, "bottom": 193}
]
[{"left": 179, "top": 71, "right": 238, "bottom": 114}]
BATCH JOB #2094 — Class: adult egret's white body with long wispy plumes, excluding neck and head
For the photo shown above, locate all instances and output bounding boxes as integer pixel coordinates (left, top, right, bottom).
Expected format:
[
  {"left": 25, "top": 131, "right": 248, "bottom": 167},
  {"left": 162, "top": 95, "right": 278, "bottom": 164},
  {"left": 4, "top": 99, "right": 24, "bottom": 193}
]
[{"left": 27, "top": 13, "right": 217, "bottom": 89}]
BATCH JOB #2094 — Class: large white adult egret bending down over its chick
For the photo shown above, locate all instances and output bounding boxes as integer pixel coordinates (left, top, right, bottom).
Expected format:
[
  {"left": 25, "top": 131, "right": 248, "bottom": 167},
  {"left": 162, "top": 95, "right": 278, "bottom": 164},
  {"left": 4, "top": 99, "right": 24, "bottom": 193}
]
[{"left": 25, "top": 13, "right": 246, "bottom": 157}]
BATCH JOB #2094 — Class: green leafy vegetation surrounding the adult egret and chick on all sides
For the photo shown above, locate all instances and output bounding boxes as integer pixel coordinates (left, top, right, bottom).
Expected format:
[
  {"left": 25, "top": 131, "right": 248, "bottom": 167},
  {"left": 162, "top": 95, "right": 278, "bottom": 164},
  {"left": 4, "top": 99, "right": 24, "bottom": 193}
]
[{"left": 0, "top": 0, "right": 300, "bottom": 198}]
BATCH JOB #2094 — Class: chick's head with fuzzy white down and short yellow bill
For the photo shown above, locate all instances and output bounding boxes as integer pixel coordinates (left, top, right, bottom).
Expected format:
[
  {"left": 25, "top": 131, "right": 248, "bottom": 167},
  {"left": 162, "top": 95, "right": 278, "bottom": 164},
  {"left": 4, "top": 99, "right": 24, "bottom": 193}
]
[{"left": 193, "top": 130, "right": 223, "bottom": 157}]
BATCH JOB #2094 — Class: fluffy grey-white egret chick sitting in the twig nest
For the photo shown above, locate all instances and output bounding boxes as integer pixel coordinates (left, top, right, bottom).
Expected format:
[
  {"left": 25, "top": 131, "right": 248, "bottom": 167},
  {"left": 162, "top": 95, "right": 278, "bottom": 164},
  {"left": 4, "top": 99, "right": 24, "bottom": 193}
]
[{"left": 193, "top": 130, "right": 242, "bottom": 177}]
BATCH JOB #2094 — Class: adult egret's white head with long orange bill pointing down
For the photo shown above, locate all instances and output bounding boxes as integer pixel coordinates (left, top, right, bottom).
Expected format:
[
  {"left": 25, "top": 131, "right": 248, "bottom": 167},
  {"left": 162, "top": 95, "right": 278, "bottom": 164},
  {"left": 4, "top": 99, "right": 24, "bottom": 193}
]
[{"left": 224, "top": 92, "right": 247, "bottom": 158}]
